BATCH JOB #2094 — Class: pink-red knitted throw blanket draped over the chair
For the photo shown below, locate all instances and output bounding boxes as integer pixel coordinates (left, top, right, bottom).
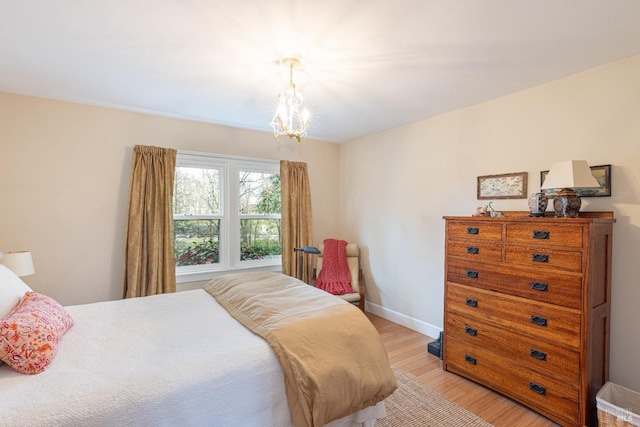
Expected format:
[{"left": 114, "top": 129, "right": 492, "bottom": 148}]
[{"left": 316, "top": 239, "right": 353, "bottom": 295}]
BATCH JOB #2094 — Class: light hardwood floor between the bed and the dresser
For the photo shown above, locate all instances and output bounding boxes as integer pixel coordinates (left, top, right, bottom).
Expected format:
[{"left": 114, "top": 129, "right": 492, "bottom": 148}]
[{"left": 366, "top": 312, "right": 558, "bottom": 427}]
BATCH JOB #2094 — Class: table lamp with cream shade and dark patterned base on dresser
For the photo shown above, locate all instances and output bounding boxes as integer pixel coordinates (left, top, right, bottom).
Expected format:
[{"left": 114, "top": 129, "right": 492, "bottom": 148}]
[{"left": 541, "top": 160, "right": 600, "bottom": 218}]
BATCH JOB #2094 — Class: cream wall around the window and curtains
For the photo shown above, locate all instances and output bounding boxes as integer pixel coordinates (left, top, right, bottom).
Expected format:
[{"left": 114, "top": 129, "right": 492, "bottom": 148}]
[{"left": 0, "top": 93, "right": 339, "bottom": 305}]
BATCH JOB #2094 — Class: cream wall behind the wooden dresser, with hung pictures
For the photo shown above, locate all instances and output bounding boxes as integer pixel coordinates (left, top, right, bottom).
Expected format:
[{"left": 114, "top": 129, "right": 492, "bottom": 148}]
[{"left": 339, "top": 56, "right": 640, "bottom": 390}]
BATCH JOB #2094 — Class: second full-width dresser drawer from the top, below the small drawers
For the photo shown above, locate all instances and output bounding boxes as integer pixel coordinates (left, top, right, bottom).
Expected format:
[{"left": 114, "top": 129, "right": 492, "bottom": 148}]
[{"left": 445, "top": 282, "right": 580, "bottom": 348}]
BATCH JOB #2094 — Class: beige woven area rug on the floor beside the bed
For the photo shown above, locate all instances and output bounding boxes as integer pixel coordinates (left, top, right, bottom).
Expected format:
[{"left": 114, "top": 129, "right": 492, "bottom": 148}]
[{"left": 376, "top": 368, "right": 492, "bottom": 427}]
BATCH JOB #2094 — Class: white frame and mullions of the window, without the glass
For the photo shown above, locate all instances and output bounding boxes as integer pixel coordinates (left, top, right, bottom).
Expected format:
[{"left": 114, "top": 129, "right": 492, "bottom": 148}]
[{"left": 174, "top": 151, "right": 282, "bottom": 283}]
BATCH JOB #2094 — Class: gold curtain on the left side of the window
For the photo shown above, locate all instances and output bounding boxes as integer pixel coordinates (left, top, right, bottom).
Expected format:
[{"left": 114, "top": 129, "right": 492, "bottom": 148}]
[{"left": 124, "top": 145, "right": 177, "bottom": 298}]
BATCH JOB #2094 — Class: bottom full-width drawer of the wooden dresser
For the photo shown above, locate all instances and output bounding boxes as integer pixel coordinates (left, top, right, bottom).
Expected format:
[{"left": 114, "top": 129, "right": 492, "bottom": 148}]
[{"left": 445, "top": 338, "right": 579, "bottom": 425}]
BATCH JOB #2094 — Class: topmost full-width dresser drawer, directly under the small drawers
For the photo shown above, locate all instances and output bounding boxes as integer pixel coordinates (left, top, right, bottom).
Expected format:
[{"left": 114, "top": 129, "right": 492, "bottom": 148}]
[{"left": 446, "top": 259, "right": 582, "bottom": 310}]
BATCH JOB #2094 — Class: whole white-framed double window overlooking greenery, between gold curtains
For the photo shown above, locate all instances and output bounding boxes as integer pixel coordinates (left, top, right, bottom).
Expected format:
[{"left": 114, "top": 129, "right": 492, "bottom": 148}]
[{"left": 173, "top": 152, "right": 282, "bottom": 282}]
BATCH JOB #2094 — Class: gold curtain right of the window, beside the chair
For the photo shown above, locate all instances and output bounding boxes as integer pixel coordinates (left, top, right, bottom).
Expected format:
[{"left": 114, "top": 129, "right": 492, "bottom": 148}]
[{"left": 280, "top": 160, "right": 312, "bottom": 283}]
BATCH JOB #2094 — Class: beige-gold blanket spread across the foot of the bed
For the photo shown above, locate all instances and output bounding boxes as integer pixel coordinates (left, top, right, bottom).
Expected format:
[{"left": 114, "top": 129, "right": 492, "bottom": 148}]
[{"left": 205, "top": 272, "right": 397, "bottom": 427}]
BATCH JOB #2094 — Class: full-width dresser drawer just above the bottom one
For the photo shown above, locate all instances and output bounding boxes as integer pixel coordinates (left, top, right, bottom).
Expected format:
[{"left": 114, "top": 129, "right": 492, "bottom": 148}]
[{"left": 445, "top": 314, "right": 580, "bottom": 387}]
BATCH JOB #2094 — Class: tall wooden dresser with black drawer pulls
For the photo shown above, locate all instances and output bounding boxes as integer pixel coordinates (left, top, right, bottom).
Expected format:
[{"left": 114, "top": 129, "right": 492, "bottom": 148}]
[{"left": 443, "top": 212, "right": 615, "bottom": 426}]
